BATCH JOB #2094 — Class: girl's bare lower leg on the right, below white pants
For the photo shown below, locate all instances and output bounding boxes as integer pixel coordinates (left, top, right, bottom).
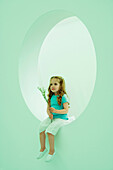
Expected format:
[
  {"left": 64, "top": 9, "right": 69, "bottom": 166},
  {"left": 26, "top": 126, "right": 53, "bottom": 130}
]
[{"left": 47, "top": 132, "right": 54, "bottom": 155}]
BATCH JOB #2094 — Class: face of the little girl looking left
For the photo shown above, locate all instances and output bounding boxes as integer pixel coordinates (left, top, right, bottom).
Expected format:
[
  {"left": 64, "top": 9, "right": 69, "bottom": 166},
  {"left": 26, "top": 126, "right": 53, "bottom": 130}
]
[{"left": 50, "top": 78, "right": 60, "bottom": 94}]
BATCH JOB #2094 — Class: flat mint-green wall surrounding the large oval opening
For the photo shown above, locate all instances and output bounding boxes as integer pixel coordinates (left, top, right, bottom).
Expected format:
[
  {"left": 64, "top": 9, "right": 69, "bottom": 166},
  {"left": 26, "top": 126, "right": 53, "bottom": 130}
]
[{"left": 0, "top": 0, "right": 113, "bottom": 170}]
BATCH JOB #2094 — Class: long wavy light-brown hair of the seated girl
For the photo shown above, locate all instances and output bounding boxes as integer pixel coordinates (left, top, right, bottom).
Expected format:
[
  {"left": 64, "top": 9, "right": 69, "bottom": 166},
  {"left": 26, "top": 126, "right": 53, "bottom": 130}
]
[{"left": 47, "top": 76, "right": 70, "bottom": 107}]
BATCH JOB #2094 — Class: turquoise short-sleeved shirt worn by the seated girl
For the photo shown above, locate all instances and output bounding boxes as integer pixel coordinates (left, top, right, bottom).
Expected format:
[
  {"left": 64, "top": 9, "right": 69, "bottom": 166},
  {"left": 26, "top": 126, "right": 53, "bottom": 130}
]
[{"left": 51, "top": 94, "right": 68, "bottom": 120}]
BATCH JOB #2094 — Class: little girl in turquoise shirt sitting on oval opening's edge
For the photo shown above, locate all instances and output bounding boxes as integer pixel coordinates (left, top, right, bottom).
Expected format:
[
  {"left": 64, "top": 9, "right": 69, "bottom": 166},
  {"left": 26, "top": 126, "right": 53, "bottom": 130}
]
[{"left": 37, "top": 76, "right": 69, "bottom": 162}]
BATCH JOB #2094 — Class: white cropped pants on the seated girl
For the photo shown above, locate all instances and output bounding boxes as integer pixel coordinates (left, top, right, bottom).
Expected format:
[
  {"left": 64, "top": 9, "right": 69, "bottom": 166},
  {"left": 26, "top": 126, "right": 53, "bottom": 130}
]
[{"left": 39, "top": 117, "right": 68, "bottom": 135}]
